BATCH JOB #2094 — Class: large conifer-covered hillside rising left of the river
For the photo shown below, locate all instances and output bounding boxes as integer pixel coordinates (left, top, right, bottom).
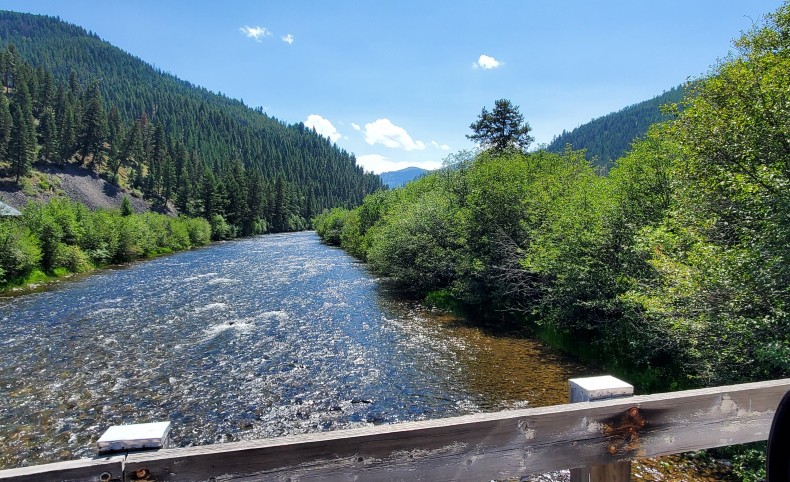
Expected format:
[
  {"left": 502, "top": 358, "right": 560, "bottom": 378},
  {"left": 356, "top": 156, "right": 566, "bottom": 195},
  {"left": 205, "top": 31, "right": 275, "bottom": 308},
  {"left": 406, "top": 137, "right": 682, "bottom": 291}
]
[{"left": 0, "top": 11, "right": 382, "bottom": 233}]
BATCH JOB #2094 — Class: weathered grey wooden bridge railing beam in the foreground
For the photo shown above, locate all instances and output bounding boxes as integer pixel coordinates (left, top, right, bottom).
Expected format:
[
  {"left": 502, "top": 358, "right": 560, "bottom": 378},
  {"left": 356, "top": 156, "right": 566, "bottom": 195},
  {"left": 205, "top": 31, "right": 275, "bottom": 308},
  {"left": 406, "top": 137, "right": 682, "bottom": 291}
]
[{"left": 0, "top": 379, "right": 790, "bottom": 481}]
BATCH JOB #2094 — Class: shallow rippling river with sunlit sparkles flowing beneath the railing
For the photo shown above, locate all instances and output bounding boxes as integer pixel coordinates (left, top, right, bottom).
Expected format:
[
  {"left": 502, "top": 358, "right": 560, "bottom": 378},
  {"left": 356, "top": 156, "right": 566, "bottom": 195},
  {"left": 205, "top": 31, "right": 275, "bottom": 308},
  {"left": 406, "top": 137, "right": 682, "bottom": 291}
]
[{"left": 0, "top": 232, "right": 592, "bottom": 468}]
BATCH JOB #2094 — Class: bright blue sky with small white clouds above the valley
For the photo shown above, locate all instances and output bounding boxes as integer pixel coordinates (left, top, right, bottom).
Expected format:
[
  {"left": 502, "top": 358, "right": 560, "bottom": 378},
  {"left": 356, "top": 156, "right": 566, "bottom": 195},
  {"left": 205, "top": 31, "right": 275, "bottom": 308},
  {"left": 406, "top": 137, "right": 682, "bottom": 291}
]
[{"left": 0, "top": 0, "right": 782, "bottom": 172}]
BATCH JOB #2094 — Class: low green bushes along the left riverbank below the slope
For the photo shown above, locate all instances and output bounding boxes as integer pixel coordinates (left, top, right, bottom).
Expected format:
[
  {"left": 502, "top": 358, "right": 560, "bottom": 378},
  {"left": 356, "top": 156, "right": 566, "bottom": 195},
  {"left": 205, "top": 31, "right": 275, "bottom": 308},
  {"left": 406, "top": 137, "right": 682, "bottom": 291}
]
[{"left": 0, "top": 198, "right": 211, "bottom": 290}]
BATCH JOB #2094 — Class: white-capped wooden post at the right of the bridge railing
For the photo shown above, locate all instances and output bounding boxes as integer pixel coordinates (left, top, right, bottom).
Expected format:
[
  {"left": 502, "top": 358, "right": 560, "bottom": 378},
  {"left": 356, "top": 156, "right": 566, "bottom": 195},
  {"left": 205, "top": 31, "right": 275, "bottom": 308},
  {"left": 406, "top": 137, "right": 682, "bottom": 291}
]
[{"left": 568, "top": 375, "right": 634, "bottom": 482}]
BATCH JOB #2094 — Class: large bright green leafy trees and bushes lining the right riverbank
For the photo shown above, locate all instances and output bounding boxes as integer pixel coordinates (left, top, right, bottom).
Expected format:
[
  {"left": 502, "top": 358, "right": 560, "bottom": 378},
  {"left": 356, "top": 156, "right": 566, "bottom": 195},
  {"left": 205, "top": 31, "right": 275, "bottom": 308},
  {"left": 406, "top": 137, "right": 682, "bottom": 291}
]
[{"left": 316, "top": 3, "right": 790, "bottom": 398}]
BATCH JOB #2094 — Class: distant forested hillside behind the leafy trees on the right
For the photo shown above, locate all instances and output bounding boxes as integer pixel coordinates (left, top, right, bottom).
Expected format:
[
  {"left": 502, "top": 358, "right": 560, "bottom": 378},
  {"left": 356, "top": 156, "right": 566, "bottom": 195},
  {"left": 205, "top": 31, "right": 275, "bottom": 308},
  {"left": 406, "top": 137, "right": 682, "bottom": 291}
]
[{"left": 547, "top": 86, "right": 686, "bottom": 170}]
